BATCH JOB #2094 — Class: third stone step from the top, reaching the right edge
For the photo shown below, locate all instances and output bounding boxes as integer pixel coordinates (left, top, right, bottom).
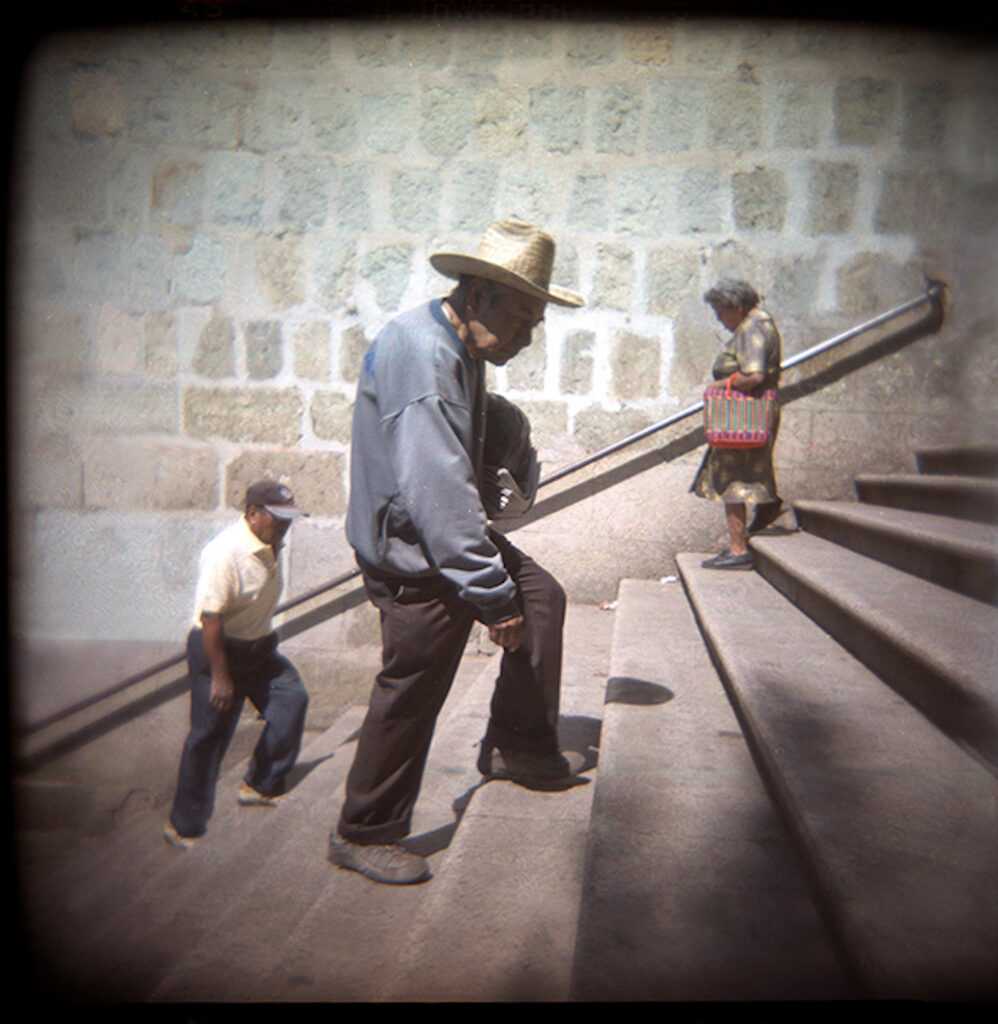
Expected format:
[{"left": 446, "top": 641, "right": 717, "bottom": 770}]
[{"left": 794, "top": 502, "right": 998, "bottom": 604}]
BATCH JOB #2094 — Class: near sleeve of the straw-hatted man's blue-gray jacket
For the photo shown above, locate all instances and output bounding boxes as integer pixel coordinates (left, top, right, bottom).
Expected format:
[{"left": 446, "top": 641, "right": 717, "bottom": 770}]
[{"left": 382, "top": 394, "right": 520, "bottom": 623}]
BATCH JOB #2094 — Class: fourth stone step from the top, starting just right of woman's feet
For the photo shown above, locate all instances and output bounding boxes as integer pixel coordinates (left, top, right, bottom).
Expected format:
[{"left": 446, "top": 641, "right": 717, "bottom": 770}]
[{"left": 751, "top": 532, "right": 998, "bottom": 770}]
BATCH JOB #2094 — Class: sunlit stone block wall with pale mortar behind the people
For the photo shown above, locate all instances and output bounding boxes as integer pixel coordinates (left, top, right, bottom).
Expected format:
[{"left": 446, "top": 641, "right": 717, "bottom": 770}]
[{"left": 9, "top": 7, "right": 998, "bottom": 641}]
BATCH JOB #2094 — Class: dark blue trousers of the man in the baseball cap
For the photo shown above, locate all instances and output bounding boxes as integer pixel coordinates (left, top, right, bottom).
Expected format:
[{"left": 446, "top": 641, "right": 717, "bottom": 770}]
[{"left": 170, "top": 630, "right": 308, "bottom": 837}]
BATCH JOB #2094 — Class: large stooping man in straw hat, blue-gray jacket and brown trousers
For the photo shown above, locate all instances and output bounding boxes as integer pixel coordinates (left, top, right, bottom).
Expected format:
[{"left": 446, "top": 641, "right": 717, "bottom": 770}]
[{"left": 329, "top": 214, "right": 583, "bottom": 885}]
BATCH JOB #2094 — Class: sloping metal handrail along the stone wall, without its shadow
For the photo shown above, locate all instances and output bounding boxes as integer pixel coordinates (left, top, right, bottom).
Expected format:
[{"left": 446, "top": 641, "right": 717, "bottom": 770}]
[{"left": 19, "top": 279, "right": 946, "bottom": 735}]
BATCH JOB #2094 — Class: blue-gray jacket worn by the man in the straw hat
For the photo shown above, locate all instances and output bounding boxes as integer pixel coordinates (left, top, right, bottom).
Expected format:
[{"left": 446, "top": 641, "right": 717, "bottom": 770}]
[{"left": 346, "top": 300, "right": 519, "bottom": 623}]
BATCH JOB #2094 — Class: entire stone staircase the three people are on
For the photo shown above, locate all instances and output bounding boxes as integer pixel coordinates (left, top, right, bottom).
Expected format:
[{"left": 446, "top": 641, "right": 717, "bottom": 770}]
[{"left": 18, "top": 445, "right": 998, "bottom": 1004}]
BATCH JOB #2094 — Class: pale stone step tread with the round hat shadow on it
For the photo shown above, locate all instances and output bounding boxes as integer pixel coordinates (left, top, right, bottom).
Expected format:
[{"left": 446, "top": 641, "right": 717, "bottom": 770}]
[{"left": 572, "top": 581, "right": 852, "bottom": 1001}]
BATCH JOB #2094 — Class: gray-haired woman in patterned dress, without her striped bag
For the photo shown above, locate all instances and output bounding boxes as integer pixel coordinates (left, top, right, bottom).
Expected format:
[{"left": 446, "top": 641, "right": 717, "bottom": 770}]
[{"left": 690, "top": 278, "right": 783, "bottom": 569}]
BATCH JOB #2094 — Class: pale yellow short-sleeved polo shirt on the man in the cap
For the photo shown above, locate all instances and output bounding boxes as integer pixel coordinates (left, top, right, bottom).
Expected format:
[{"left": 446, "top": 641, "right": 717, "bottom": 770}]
[{"left": 194, "top": 516, "right": 284, "bottom": 640}]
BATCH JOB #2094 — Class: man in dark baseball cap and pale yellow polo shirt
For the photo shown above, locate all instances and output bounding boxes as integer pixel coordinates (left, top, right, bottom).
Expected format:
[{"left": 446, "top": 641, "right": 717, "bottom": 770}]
[{"left": 163, "top": 480, "right": 308, "bottom": 849}]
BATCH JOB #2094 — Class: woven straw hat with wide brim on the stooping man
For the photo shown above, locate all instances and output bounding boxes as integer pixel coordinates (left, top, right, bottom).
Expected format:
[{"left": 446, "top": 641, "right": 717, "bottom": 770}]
[{"left": 430, "top": 220, "right": 585, "bottom": 306}]
